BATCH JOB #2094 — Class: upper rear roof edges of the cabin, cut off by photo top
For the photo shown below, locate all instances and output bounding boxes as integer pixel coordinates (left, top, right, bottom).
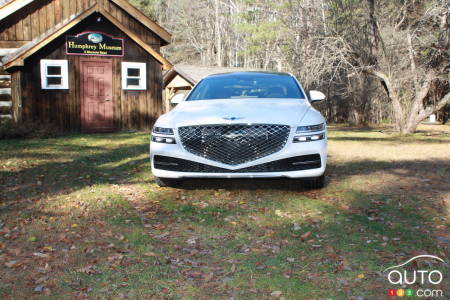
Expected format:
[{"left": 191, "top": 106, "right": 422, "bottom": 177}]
[{"left": 0, "top": 0, "right": 172, "bottom": 46}]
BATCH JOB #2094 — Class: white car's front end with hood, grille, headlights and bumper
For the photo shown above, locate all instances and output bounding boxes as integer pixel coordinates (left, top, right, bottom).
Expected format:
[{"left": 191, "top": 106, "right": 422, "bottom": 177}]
[{"left": 150, "top": 71, "right": 327, "bottom": 186}]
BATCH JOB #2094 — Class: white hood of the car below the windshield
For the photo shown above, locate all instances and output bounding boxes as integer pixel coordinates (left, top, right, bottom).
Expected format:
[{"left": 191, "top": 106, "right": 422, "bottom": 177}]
[{"left": 162, "top": 98, "right": 311, "bottom": 127}]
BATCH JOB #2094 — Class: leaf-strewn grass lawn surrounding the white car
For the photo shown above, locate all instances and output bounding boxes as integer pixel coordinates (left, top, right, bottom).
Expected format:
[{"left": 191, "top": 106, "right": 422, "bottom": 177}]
[{"left": 0, "top": 126, "right": 450, "bottom": 299}]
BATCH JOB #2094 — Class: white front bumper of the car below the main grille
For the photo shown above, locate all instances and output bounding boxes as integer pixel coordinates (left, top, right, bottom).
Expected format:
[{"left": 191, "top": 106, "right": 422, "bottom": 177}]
[{"left": 150, "top": 137, "right": 327, "bottom": 179}]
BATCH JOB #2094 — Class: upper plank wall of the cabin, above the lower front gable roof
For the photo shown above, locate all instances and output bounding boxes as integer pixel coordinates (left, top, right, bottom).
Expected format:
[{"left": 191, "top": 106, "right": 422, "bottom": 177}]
[{"left": 0, "top": 0, "right": 161, "bottom": 52}]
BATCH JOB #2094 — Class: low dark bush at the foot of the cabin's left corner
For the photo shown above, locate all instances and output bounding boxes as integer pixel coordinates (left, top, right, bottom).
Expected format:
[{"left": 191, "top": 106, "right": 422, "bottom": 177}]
[{"left": 0, "top": 120, "right": 61, "bottom": 139}]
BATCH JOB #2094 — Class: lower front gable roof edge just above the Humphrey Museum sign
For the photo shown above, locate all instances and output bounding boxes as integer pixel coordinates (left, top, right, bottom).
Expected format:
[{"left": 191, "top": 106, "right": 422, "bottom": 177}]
[{"left": 2, "top": 4, "right": 172, "bottom": 70}]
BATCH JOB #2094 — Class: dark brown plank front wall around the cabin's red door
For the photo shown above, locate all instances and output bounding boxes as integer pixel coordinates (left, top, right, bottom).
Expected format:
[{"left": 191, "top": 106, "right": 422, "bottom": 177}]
[{"left": 21, "top": 14, "right": 163, "bottom": 131}]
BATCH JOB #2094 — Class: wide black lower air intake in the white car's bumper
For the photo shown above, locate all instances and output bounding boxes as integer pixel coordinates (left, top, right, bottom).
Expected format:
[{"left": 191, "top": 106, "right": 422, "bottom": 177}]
[{"left": 153, "top": 154, "right": 322, "bottom": 173}]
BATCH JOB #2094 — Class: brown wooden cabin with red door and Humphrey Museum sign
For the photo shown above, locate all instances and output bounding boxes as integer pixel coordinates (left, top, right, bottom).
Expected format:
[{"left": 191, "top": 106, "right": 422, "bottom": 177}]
[{"left": 0, "top": 0, "right": 172, "bottom": 132}]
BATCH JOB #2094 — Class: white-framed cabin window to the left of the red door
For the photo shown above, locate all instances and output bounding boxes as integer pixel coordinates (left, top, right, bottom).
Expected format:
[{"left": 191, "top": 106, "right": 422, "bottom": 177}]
[{"left": 41, "top": 59, "right": 69, "bottom": 90}]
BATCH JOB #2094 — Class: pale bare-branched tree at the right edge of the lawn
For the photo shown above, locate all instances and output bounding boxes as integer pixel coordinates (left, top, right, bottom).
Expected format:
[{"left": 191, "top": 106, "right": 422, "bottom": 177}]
[{"left": 342, "top": 0, "right": 450, "bottom": 133}]
